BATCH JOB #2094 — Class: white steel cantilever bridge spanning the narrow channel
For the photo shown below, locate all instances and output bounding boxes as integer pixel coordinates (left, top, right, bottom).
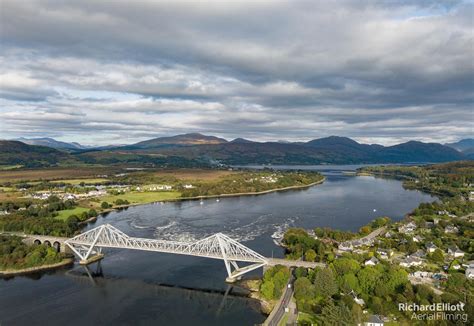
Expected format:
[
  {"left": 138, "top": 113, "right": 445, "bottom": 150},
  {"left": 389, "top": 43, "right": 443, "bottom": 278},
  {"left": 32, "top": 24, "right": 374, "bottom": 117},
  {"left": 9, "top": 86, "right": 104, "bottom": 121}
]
[{"left": 65, "top": 224, "right": 322, "bottom": 282}]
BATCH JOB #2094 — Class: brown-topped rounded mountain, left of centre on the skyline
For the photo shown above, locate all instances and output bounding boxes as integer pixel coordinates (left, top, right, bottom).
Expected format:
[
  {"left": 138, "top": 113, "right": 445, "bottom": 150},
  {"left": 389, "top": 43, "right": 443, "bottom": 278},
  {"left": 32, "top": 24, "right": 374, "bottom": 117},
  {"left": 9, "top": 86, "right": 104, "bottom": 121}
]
[{"left": 128, "top": 133, "right": 227, "bottom": 149}]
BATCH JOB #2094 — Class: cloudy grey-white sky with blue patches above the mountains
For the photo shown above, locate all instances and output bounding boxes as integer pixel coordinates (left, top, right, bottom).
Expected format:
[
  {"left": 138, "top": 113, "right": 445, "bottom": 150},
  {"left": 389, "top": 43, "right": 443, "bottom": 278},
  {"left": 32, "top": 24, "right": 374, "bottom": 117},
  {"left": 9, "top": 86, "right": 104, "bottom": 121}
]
[{"left": 0, "top": 0, "right": 474, "bottom": 145}]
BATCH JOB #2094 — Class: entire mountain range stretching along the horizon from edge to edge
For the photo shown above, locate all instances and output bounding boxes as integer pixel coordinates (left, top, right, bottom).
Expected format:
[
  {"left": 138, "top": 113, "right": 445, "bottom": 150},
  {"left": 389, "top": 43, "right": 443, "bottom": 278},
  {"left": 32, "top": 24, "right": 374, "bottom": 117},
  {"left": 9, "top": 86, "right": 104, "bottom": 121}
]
[{"left": 0, "top": 133, "right": 474, "bottom": 166}]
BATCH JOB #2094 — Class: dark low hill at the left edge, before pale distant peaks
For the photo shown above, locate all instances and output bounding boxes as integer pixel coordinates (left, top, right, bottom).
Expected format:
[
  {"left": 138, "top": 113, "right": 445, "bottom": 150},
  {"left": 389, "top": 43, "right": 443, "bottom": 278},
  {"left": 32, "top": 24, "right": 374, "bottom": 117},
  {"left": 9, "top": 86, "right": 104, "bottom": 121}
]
[{"left": 0, "top": 140, "right": 71, "bottom": 167}]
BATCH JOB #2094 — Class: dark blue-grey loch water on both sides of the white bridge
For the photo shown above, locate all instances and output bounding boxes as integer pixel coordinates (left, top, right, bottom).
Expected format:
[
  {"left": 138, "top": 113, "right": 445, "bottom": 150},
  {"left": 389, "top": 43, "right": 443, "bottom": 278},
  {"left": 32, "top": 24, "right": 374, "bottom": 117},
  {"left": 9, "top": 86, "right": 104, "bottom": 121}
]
[{"left": 0, "top": 166, "right": 434, "bottom": 325}]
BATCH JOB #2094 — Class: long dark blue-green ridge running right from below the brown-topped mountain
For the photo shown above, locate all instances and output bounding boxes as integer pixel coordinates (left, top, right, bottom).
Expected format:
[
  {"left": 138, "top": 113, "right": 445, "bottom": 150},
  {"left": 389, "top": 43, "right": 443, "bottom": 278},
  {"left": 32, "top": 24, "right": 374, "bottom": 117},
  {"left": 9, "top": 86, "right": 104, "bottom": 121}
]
[{"left": 122, "top": 136, "right": 467, "bottom": 165}]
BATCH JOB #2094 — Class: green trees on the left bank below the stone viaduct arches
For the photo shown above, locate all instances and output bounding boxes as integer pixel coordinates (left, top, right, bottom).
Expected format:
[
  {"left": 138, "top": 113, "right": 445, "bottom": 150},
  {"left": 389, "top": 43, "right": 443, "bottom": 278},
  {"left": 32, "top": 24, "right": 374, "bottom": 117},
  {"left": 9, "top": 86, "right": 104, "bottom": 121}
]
[{"left": 0, "top": 235, "right": 64, "bottom": 270}]
